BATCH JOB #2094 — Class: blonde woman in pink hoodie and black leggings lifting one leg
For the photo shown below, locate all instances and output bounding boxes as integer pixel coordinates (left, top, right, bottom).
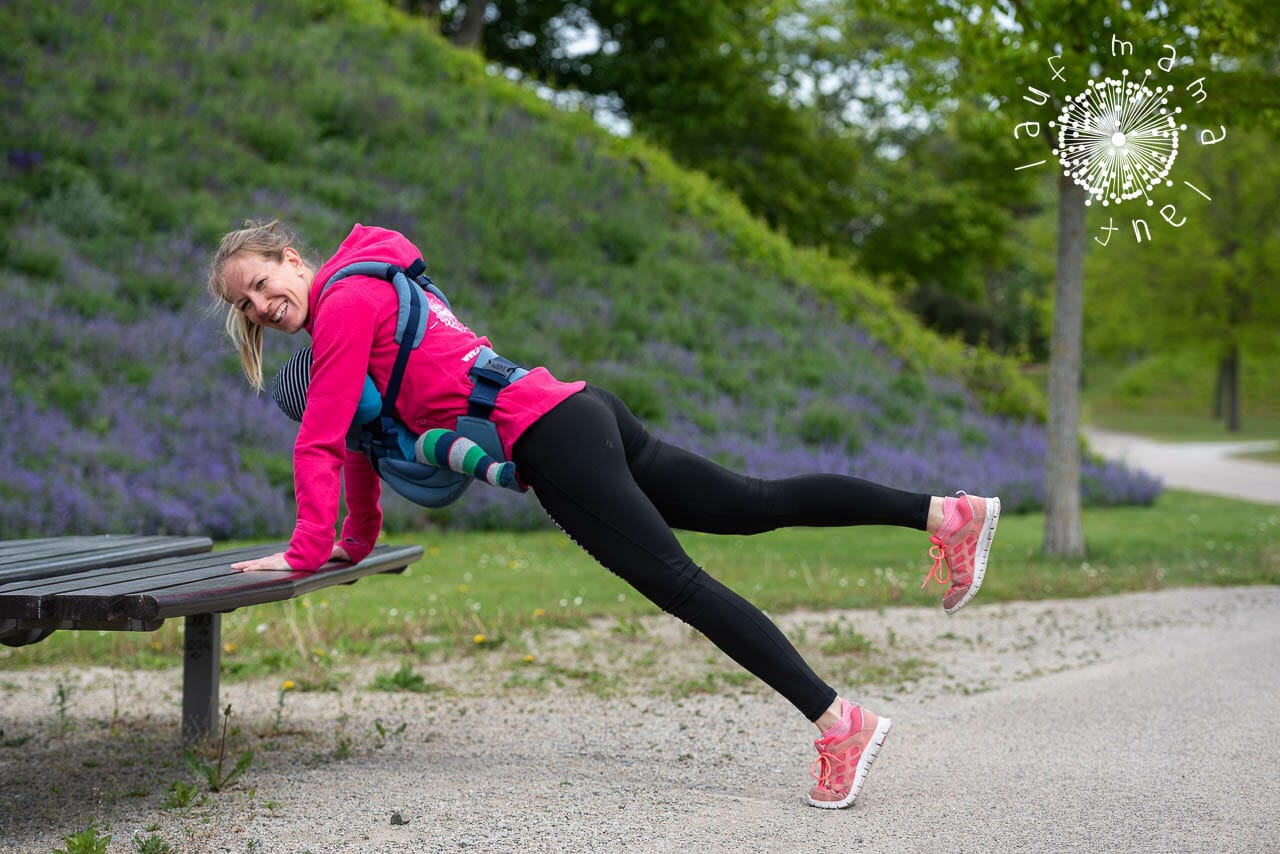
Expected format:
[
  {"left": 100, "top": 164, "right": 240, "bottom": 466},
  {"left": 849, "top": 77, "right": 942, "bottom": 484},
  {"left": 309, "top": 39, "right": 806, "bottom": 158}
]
[{"left": 209, "top": 222, "right": 1000, "bottom": 808}]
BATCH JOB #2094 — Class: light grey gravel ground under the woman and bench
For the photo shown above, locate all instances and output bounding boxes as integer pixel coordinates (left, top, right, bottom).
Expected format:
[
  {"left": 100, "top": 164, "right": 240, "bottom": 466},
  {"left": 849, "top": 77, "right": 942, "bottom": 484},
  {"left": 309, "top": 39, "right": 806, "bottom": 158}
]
[{"left": 0, "top": 586, "right": 1280, "bottom": 854}]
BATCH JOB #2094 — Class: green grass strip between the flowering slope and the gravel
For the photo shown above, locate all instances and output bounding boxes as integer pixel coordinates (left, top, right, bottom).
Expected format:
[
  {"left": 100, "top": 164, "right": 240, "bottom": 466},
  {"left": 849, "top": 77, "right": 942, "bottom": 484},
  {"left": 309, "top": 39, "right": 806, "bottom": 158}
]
[{"left": 0, "top": 492, "right": 1280, "bottom": 688}]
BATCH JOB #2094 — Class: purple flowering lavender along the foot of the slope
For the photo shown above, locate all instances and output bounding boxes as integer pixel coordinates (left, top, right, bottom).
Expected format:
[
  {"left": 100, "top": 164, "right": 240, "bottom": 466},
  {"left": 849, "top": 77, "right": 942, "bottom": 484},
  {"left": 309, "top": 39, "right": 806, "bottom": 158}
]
[{"left": 0, "top": 263, "right": 1160, "bottom": 538}]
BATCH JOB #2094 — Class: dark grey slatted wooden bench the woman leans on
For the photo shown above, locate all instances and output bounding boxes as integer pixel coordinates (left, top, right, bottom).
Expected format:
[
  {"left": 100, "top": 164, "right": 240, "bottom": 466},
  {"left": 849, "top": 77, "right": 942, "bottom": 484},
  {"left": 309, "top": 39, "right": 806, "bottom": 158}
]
[{"left": 0, "top": 535, "right": 422, "bottom": 744}]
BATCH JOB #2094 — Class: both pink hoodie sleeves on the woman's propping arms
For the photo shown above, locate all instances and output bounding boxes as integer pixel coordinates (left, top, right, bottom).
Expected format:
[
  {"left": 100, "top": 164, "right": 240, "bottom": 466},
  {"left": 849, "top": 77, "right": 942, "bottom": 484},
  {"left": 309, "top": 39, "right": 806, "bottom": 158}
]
[{"left": 284, "top": 284, "right": 381, "bottom": 572}]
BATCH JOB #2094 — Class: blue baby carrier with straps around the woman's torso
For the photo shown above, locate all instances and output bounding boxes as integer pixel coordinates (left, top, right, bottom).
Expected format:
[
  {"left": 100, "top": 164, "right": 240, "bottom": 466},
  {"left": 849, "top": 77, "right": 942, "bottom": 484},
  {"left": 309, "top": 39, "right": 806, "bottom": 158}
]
[{"left": 271, "top": 259, "right": 529, "bottom": 507}]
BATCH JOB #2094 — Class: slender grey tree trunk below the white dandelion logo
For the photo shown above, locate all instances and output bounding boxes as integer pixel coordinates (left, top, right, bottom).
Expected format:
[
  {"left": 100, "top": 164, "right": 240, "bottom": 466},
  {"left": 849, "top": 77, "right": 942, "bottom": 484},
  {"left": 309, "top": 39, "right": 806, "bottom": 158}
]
[{"left": 1044, "top": 175, "right": 1084, "bottom": 557}]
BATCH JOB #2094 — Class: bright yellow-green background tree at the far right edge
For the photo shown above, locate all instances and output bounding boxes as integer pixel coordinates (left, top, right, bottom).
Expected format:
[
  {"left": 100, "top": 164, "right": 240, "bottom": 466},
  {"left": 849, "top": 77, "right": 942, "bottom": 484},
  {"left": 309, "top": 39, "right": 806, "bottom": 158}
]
[{"left": 1085, "top": 125, "right": 1280, "bottom": 431}]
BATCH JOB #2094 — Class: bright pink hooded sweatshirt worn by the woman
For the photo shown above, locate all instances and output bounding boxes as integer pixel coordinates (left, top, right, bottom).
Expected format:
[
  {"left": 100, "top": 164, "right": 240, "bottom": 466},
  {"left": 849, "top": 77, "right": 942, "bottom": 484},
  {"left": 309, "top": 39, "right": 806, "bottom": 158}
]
[{"left": 284, "top": 224, "right": 585, "bottom": 571}]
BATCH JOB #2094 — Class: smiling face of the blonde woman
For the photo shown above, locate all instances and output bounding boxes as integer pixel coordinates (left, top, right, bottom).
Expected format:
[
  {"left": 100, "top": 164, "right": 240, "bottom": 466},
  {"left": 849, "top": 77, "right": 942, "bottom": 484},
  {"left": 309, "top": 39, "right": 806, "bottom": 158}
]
[{"left": 223, "top": 247, "right": 315, "bottom": 335}]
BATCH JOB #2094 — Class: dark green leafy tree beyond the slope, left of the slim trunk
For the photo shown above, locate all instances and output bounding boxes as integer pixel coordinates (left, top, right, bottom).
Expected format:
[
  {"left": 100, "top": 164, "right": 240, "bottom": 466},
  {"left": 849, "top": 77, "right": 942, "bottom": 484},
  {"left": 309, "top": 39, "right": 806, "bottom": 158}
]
[{"left": 851, "top": 104, "right": 1043, "bottom": 355}]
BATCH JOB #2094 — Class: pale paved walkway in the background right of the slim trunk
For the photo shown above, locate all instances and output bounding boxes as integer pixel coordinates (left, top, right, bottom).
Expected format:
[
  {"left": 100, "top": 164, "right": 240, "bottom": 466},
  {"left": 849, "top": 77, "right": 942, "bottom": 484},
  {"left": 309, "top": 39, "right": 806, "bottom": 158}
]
[{"left": 1084, "top": 428, "right": 1280, "bottom": 504}]
